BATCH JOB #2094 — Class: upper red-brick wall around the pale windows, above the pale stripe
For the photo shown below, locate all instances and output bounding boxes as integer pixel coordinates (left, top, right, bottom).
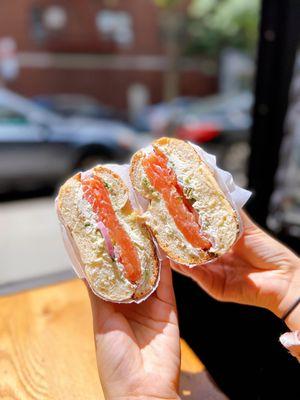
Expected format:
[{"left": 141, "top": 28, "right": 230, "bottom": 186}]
[{"left": 0, "top": 0, "right": 162, "bottom": 54}]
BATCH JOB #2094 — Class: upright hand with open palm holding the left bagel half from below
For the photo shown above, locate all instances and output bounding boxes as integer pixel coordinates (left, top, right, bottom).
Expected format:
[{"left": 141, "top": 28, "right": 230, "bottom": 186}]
[{"left": 89, "top": 262, "right": 180, "bottom": 400}]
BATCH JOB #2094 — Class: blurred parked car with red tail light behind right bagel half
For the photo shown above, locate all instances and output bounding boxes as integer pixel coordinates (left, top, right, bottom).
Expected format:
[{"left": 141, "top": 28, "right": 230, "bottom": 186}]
[{"left": 134, "top": 91, "right": 253, "bottom": 185}]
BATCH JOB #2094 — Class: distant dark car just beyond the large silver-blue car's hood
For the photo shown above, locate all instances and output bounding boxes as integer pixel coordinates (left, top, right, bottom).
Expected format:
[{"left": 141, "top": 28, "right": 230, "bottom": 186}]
[{"left": 33, "top": 93, "right": 125, "bottom": 120}]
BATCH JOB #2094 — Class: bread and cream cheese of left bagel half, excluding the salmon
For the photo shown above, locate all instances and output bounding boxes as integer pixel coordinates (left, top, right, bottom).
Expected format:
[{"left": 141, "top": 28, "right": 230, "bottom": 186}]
[{"left": 57, "top": 166, "right": 159, "bottom": 302}]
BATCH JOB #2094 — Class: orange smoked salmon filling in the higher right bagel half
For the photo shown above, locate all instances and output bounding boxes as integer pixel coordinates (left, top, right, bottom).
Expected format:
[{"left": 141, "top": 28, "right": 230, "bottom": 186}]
[{"left": 142, "top": 146, "right": 211, "bottom": 250}]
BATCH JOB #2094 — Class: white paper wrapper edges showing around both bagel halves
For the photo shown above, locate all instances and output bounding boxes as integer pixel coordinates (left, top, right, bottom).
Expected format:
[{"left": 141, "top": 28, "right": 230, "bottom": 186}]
[{"left": 56, "top": 143, "right": 251, "bottom": 303}]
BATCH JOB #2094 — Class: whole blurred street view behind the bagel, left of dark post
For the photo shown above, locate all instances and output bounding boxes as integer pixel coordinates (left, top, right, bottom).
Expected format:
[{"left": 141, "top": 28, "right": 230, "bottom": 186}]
[{"left": 0, "top": 0, "right": 259, "bottom": 288}]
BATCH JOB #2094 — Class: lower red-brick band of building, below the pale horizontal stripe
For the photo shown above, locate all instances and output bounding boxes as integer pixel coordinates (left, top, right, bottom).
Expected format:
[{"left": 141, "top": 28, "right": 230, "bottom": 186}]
[{"left": 9, "top": 68, "right": 216, "bottom": 109}]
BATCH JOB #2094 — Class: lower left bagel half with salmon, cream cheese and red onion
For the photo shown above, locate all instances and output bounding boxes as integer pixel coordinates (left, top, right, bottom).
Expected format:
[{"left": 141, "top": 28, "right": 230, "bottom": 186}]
[{"left": 57, "top": 166, "right": 159, "bottom": 302}]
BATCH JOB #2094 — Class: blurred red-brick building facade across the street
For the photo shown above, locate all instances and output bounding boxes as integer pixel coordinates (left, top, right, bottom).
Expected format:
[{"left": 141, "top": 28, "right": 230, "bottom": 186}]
[{"left": 0, "top": 0, "right": 217, "bottom": 109}]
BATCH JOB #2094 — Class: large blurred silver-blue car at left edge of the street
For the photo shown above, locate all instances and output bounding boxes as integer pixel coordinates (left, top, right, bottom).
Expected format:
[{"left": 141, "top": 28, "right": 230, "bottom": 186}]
[{"left": 0, "top": 88, "right": 142, "bottom": 192}]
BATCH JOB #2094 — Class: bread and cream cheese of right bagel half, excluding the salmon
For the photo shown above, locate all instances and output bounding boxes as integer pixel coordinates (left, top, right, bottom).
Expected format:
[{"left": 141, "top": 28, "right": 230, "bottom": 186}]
[{"left": 130, "top": 138, "right": 239, "bottom": 265}]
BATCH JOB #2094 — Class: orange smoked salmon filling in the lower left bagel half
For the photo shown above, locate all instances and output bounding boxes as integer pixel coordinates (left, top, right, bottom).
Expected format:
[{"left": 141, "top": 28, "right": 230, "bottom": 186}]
[{"left": 81, "top": 175, "right": 141, "bottom": 283}]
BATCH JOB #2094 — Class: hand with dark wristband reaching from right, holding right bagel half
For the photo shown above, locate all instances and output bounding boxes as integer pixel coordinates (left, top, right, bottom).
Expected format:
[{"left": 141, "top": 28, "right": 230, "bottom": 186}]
[{"left": 171, "top": 213, "right": 300, "bottom": 330}]
